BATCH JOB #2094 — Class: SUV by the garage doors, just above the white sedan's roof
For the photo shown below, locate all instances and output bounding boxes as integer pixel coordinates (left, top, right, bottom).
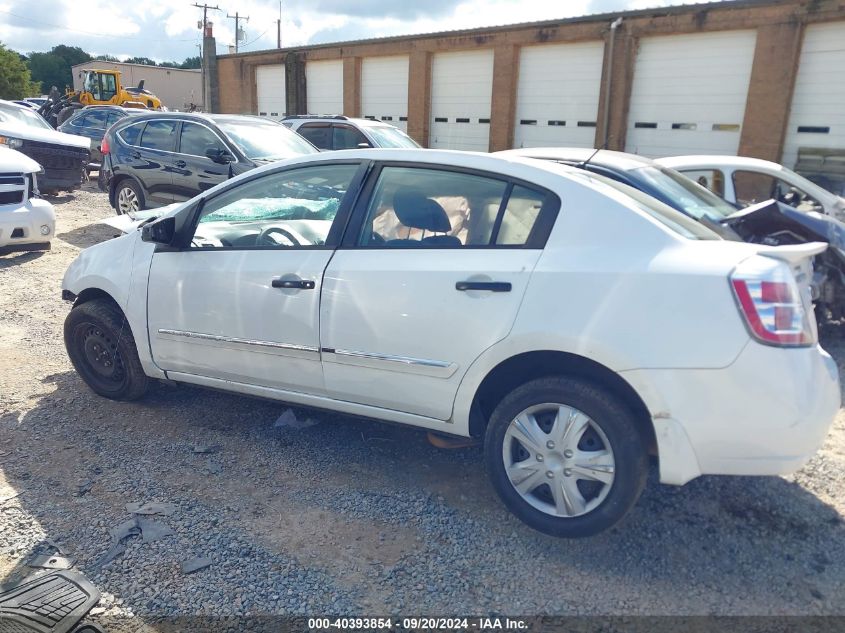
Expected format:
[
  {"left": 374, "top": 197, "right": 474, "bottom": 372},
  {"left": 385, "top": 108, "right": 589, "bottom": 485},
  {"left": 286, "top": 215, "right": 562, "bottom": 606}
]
[{"left": 282, "top": 114, "right": 419, "bottom": 151}]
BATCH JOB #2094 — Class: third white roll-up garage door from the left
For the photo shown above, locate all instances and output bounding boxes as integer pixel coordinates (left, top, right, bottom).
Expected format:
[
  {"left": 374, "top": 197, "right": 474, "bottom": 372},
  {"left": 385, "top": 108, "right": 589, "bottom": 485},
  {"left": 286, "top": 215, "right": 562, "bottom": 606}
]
[{"left": 361, "top": 55, "right": 408, "bottom": 130}]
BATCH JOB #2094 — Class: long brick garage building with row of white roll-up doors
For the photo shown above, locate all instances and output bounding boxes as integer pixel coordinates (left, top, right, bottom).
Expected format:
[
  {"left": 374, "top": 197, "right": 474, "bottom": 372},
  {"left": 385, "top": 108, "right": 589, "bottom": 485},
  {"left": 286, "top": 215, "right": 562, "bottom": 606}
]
[{"left": 216, "top": 0, "right": 845, "bottom": 178}]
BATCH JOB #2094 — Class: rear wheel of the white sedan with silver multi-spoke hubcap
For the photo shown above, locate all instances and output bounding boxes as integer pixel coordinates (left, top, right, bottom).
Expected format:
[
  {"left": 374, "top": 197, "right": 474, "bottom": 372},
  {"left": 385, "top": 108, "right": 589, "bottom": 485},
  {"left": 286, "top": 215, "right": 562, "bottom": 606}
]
[{"left": 484, "top": 377, "right": 648, "bottom": 538}]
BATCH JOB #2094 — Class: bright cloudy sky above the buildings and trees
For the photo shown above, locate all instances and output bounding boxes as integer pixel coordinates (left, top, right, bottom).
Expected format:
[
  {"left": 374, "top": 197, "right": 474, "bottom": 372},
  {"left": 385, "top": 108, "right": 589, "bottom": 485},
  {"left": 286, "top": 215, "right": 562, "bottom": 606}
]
[{"left": 0, "top": 0, "right": 720, "bottom": 62}]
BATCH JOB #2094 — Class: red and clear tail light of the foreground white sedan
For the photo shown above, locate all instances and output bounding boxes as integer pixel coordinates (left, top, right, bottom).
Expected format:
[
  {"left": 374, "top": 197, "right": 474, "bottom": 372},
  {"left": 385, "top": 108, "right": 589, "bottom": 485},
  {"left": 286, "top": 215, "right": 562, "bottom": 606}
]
[{"left": 731, "top": 256, "right": 818, "bottom": 347}]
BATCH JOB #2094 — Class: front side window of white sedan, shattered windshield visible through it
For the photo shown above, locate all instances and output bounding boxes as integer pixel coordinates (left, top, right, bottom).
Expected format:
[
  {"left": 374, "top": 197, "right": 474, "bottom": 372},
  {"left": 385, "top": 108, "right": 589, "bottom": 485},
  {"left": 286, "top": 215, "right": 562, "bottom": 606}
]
[{"left": 191, "top": 164, "right": 358, "bottom": 249}]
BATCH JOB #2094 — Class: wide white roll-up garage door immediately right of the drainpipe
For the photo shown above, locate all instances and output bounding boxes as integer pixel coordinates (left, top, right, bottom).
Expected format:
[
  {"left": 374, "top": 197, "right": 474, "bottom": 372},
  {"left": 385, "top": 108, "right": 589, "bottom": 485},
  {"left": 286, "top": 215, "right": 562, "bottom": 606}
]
[{"left": 625, "top": 31, "right": 757, "bottom": 157}]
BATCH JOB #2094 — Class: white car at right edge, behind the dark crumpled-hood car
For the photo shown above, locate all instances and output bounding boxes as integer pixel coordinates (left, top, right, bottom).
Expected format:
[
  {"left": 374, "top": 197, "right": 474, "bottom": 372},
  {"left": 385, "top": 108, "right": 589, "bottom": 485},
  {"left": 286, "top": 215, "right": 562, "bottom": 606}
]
[{"left": 655, "top": 156, "right": 845, "bottom": 221}]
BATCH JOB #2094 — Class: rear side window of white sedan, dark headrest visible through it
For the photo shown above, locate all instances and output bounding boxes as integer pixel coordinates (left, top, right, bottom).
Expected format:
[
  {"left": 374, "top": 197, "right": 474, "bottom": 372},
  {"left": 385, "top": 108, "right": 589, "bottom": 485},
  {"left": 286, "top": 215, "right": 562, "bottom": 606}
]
[{"left": 358, "top": 167, "right": 558, "bottom": 248}]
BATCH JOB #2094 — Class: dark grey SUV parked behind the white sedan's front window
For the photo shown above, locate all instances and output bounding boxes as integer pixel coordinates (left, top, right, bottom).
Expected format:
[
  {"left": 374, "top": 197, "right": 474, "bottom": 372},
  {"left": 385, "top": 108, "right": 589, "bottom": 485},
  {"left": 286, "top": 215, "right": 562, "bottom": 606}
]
[{"left": 97, "top": 112, "right": 318, "bottom": 214}]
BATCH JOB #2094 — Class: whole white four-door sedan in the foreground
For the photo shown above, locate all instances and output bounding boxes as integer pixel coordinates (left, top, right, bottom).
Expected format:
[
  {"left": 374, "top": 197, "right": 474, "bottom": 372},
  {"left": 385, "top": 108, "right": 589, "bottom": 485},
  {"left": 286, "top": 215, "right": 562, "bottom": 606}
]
[{"left": 62, "top": 150, "right": 840, "bottom": 536}]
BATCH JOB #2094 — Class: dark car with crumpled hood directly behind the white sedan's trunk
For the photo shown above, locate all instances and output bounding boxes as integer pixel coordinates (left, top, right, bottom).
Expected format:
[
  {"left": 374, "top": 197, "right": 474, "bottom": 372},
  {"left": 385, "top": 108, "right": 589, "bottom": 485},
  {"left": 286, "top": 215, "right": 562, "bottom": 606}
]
[{"left": 501, "top": 147, "right": 845, "bottom": 322}]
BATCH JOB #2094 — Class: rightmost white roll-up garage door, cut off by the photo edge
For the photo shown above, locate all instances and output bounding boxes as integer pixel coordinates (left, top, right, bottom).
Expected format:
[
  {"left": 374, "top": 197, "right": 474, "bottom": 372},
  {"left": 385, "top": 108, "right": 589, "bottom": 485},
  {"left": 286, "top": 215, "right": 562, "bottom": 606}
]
[{"left": 783, "top": 22, "right": 845, "bottom": 174}]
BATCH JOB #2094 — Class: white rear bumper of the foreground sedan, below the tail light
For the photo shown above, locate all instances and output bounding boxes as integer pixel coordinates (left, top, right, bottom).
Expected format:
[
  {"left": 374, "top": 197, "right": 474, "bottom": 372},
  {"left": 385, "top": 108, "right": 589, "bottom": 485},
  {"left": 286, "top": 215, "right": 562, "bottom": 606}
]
[{"left": 623, "top": 342, "right": 841, "bottom": 485}]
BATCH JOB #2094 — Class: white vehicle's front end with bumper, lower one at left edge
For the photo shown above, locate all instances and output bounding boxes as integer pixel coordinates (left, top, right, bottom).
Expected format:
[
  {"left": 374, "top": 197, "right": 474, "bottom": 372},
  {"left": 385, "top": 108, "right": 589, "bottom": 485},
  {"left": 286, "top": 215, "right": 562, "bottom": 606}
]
[{"left": 0, "top": 147, "right": 56, "bottom": 253}]
